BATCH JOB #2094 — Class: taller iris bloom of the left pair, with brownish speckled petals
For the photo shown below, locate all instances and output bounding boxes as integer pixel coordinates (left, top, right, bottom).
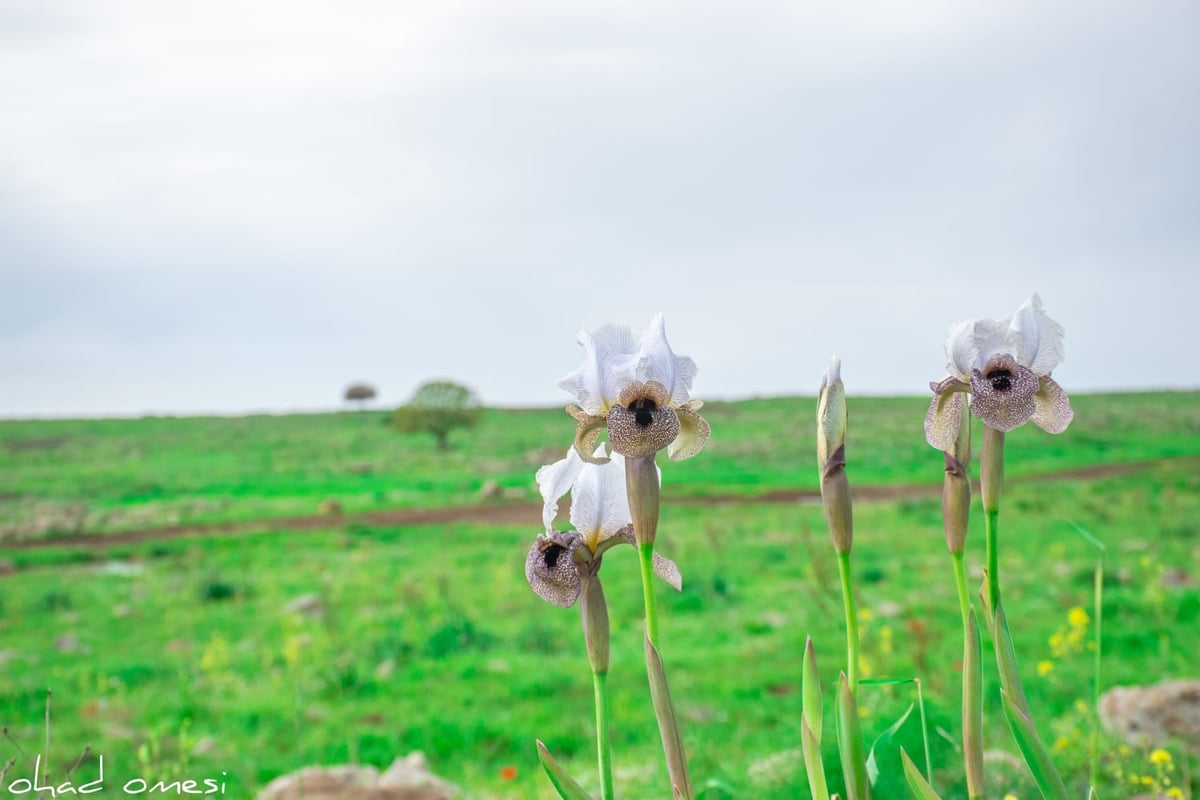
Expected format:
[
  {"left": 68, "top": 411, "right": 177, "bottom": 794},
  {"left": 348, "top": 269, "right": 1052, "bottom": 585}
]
[{"left": 558, "top": 314, "right": 709, "bottom": 464}]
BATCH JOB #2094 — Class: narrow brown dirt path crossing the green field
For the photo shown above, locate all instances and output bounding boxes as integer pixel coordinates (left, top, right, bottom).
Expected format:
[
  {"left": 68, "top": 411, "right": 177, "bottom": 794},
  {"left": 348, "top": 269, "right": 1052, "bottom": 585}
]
[{"left": 0, "top": 457, "right": 1180, "bottom": 549}]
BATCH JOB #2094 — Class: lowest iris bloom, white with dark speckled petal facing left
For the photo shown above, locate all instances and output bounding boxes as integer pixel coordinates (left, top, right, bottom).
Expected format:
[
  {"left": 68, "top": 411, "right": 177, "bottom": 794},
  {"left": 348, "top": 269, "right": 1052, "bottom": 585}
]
[{"left": 526, "top": 445, "right": 683, "bottom": 607}]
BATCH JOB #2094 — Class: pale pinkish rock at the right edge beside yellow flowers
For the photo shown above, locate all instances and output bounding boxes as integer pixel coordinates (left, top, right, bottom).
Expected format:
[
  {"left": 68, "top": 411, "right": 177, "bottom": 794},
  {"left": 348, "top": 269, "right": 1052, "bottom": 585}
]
[{"left": 1100, "top": 680, "right": 1200, "bottom": 753}]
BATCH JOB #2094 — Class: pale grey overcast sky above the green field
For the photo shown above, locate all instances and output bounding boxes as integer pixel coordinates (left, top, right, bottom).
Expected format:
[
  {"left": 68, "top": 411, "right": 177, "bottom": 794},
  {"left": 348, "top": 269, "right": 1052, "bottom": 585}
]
[{"left": 0, "top": 0, "right": 1200, "bottom": 416}]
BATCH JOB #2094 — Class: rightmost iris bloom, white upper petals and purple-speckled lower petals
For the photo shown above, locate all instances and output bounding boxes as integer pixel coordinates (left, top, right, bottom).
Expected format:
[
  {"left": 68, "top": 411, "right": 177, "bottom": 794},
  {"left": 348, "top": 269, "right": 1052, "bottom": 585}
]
[{"left": 925, "top": 295, "right": 1074, "bottom": 451}]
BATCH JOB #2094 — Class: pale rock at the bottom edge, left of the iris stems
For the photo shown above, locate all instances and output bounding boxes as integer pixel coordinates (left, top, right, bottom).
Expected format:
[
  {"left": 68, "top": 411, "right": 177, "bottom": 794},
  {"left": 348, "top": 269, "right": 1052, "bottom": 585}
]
[{"left": 258, "top": 752, "right": 457, "bottom": 800}]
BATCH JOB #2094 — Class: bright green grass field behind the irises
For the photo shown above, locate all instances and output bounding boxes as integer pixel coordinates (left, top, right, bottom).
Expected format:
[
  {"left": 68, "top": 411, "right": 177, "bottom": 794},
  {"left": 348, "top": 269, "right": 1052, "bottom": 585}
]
[{"left": 0, "top": 393, "right": 1200, "bottom": 800}]
